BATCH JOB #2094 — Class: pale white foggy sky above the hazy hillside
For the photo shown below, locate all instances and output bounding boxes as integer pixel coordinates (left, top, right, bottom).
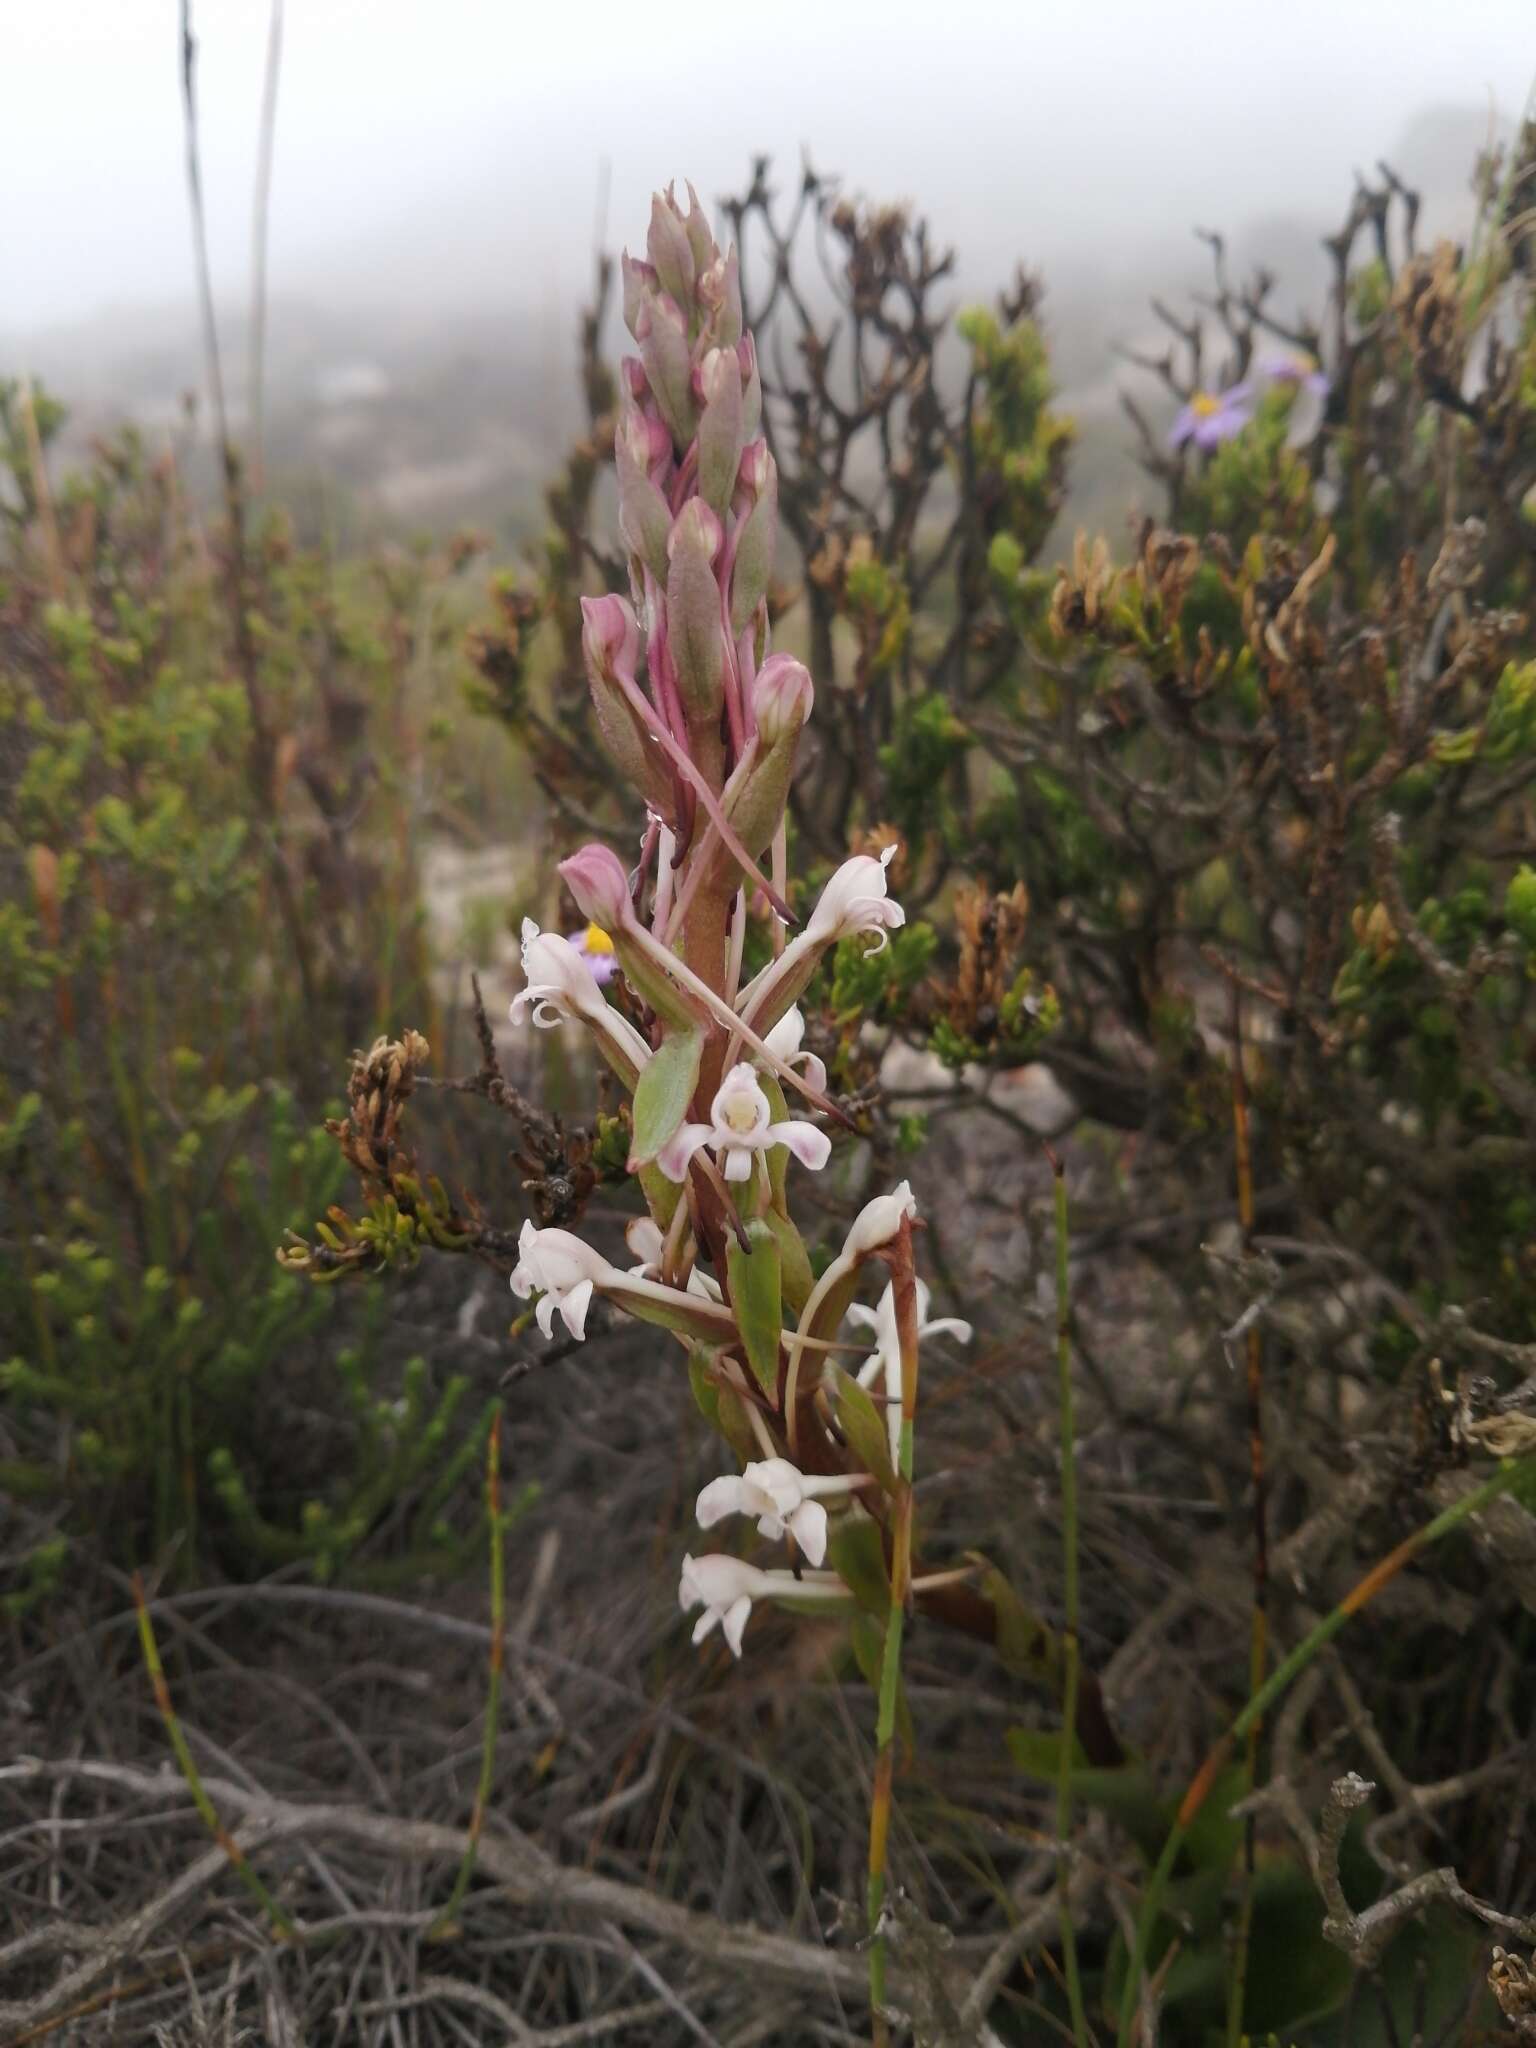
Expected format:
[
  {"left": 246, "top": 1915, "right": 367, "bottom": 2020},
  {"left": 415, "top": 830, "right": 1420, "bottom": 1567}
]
[{"left": 0, "top": 0, "right": 1536, "bottom": 346}]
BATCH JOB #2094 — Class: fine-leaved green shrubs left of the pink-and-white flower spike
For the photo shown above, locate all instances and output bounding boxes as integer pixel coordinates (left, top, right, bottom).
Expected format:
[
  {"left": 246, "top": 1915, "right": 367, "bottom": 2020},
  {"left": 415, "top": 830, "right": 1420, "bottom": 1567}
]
[{"left": 0, "top": 387, "right": 512, "bottom": 1608}]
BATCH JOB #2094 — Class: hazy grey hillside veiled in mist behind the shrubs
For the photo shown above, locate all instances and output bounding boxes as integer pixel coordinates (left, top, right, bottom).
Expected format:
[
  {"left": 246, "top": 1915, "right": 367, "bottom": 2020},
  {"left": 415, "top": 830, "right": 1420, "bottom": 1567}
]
[{"left": 0, "top": 104, "right": 1495, "bottom": 541}]
